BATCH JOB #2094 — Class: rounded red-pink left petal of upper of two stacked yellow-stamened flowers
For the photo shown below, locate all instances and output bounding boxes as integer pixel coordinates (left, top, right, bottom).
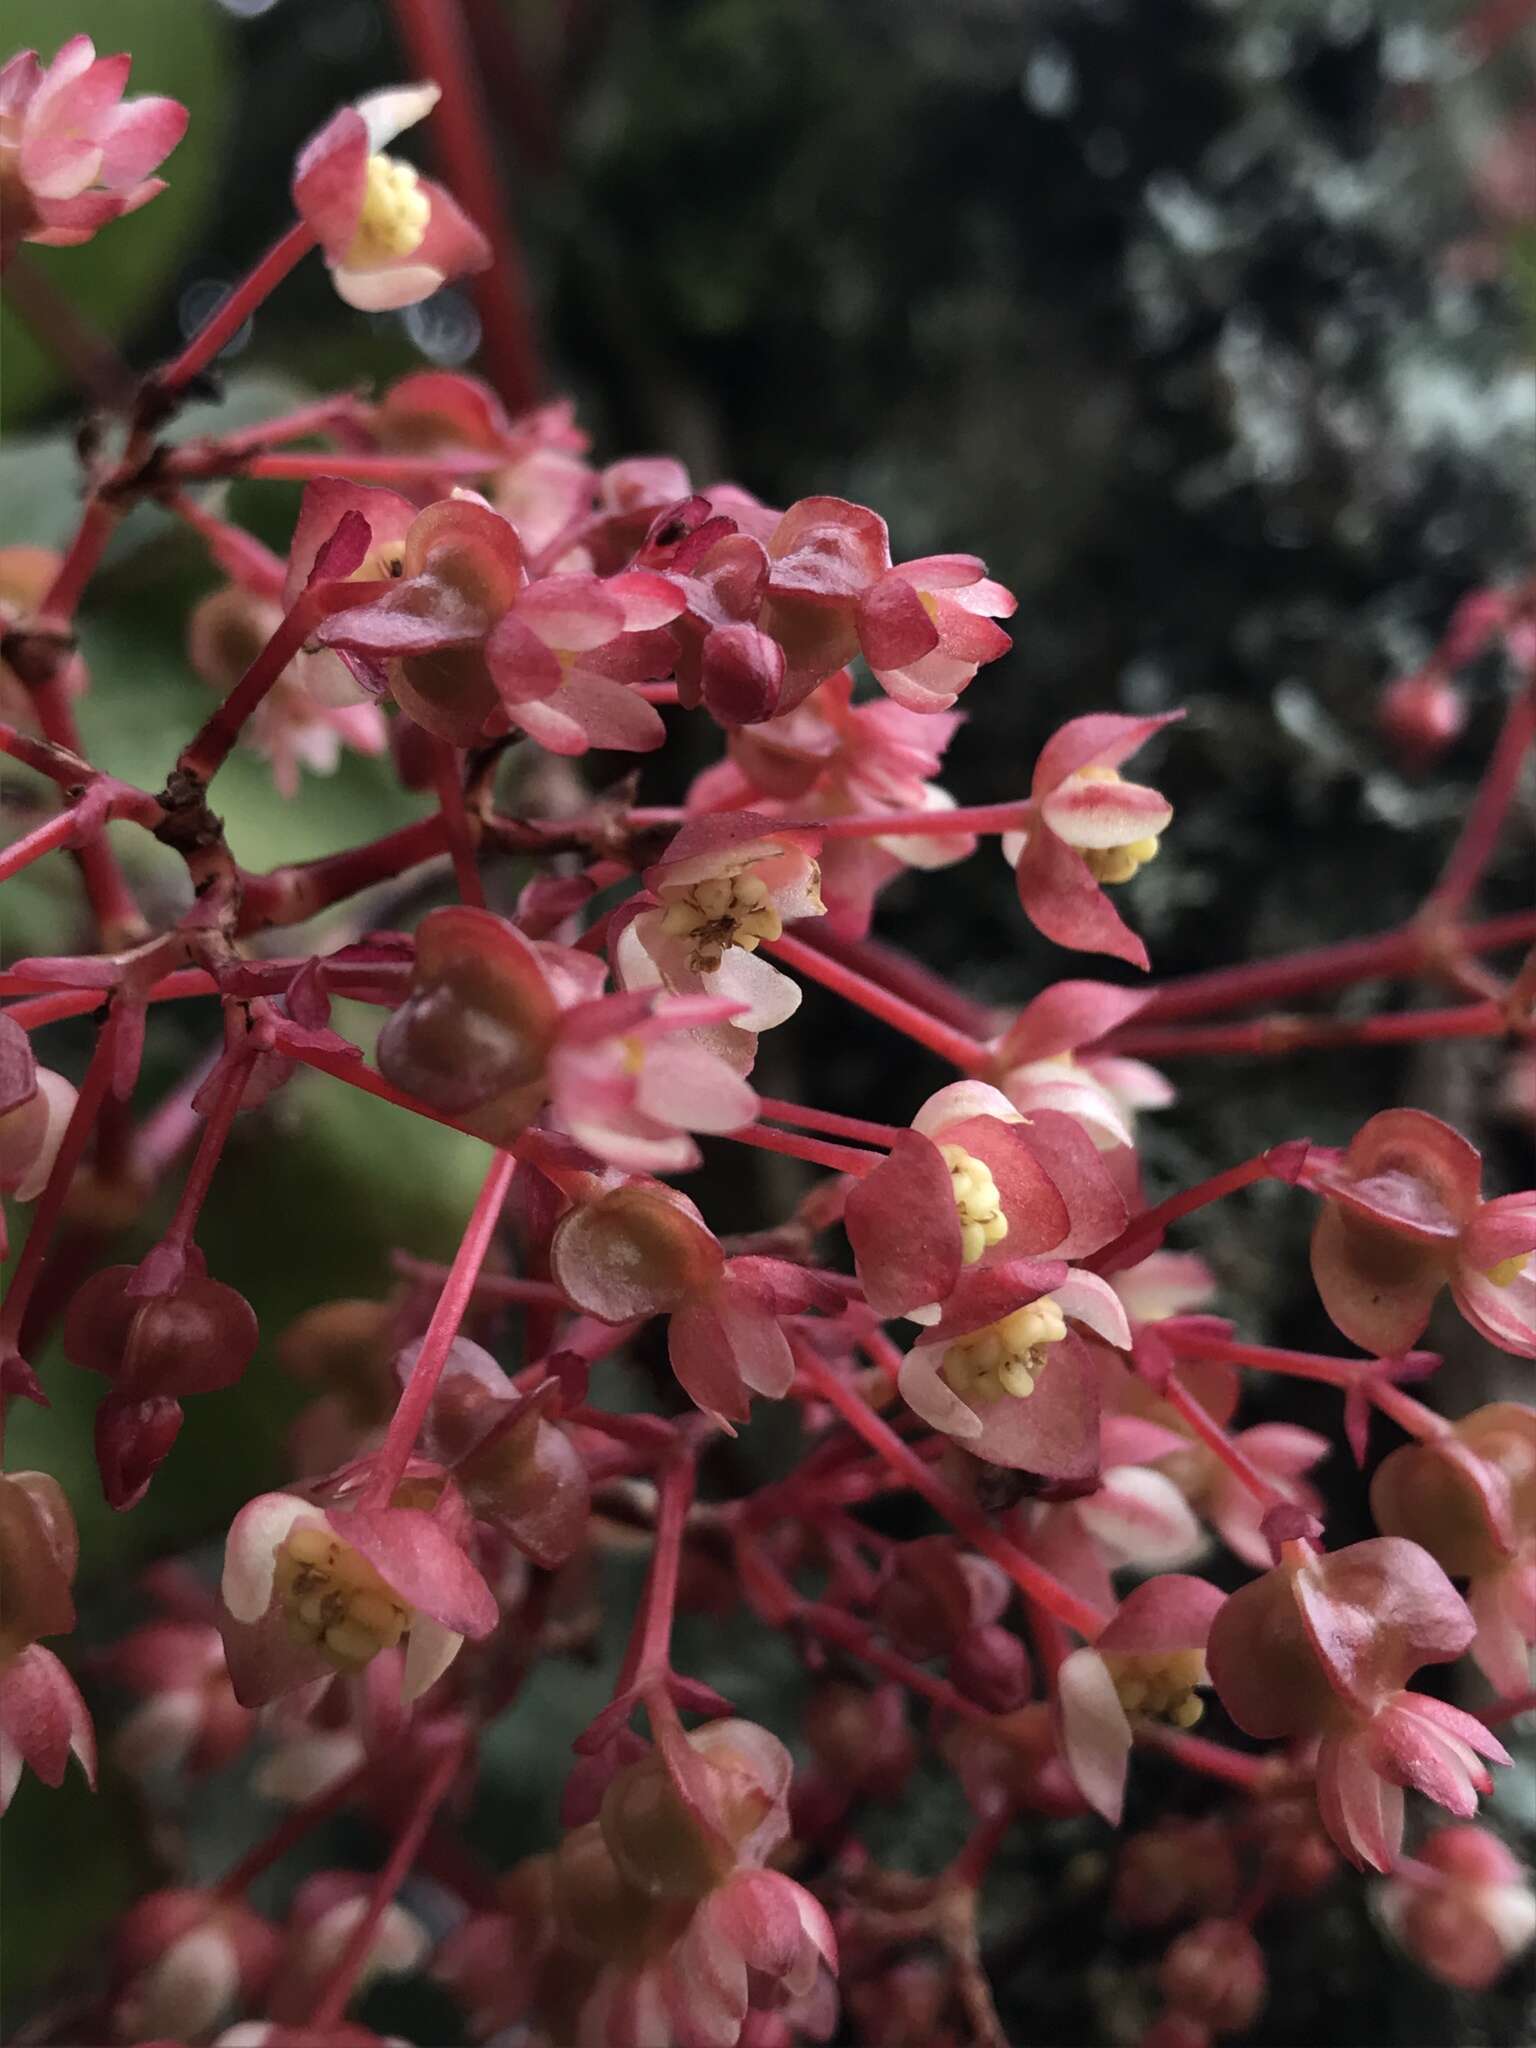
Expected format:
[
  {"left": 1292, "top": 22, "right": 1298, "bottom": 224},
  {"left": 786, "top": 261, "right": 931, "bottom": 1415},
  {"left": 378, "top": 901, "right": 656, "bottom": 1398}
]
[{"left": 844, "top": 1130, "right": 961, "bottom": 1315}]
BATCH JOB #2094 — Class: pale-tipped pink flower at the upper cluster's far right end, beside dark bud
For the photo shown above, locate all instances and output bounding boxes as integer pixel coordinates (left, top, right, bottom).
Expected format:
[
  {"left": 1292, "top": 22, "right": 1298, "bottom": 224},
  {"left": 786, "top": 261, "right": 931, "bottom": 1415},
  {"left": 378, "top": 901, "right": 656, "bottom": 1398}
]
[{"left": 858, "top": 555, "right": 1018, "bottom": 711}]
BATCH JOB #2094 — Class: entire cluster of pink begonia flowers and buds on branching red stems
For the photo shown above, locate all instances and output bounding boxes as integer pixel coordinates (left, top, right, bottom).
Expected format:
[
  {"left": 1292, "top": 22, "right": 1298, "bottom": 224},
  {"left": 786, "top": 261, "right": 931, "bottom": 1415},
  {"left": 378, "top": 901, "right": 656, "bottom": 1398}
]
[{"left": 0, "top": 37, "right": 1536, "bottom": 2048}]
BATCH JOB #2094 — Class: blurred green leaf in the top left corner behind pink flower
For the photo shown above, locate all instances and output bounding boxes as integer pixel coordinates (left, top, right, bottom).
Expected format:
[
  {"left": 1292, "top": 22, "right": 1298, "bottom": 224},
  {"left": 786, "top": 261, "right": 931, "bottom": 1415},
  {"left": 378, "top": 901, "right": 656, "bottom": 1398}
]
[{"left": 0, "top": 0, "right": 231, "bottom": 424}]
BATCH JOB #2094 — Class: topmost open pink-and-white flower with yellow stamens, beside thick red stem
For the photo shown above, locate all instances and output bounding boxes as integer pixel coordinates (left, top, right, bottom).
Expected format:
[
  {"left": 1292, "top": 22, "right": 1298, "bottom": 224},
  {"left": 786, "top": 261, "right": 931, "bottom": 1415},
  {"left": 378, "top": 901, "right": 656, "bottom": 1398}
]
[{"left": 293, "top": 86, "right": 492, "bottom": 313}]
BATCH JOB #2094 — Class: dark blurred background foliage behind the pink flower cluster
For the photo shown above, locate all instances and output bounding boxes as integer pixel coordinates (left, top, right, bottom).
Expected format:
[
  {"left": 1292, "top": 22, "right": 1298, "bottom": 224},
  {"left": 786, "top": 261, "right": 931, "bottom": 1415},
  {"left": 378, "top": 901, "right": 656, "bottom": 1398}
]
[{"left": 6, "top": 0, "right": 1536, "bottom": 2048}]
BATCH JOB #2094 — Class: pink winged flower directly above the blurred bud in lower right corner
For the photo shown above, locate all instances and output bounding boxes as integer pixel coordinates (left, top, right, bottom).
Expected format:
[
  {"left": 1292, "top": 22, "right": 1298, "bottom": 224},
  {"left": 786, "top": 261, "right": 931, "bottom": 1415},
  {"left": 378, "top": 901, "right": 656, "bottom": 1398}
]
[{"left": 1210, "top": 1536, "right": 1509, "bottom": 1870}]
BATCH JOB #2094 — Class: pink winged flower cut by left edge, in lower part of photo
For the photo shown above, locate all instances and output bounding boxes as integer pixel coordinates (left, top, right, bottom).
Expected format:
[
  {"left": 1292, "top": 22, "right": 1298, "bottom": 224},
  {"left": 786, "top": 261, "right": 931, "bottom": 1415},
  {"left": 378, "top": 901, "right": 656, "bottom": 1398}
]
[{"left": 0, "top": 1473, "right": 96, "bottom": 1812}]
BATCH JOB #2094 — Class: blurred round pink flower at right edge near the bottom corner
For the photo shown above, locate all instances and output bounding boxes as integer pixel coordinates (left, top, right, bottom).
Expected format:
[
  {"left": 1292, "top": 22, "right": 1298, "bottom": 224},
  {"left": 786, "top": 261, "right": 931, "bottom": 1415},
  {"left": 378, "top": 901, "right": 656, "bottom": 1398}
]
[{"left": 1376, "top": 1827, "right": 1536, "bottom": 1991}]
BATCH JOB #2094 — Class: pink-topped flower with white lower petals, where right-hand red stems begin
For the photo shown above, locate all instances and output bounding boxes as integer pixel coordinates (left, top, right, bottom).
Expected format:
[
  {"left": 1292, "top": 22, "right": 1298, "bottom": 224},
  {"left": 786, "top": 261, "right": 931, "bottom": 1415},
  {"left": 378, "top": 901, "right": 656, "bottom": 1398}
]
[{"left": 993, "top": 981, "right": 1174, "bottom": 1151}]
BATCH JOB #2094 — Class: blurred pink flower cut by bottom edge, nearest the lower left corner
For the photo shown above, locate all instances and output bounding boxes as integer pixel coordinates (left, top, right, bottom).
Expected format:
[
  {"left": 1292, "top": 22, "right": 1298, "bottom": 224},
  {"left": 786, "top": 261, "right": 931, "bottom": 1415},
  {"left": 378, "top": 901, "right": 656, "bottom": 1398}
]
[{"left": 111, "top": 1888, "right": 283, "bottom": 2042}]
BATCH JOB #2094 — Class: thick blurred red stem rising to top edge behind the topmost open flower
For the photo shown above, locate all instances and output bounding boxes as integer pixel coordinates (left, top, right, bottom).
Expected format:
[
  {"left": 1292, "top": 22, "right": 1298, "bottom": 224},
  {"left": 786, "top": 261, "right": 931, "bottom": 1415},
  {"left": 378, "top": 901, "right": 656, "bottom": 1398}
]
[{"left": 393, "top": 0, "right": 545, "bottom": 412}]
